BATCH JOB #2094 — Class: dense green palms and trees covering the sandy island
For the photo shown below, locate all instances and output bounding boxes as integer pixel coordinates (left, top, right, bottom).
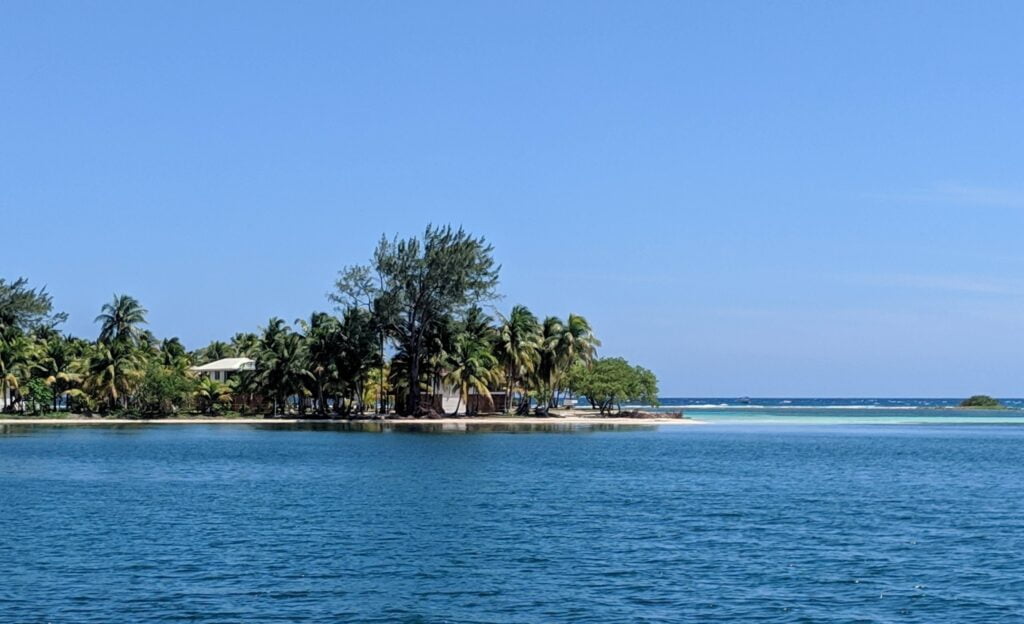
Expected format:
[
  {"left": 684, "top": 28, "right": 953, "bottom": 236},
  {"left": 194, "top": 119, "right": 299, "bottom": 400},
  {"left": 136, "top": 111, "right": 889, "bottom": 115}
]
[{"left": 0, "top": 227, "right": 657, "bottom": 416}]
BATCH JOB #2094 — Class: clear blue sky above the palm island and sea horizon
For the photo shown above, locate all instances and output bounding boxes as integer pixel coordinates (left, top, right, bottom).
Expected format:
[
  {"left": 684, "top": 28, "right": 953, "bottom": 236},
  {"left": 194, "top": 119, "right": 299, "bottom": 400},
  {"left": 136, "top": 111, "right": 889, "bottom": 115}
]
[{"left": 0, "top": 1, "right": 1024, "bottom": 397}]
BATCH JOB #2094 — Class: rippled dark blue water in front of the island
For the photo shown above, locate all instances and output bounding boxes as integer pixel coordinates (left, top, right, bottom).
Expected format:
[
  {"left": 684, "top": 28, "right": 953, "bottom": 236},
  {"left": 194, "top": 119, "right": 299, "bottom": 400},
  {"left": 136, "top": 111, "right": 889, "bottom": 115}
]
[{"left": 0, "top": 424, "right": 1024, "bottom": 624}]
